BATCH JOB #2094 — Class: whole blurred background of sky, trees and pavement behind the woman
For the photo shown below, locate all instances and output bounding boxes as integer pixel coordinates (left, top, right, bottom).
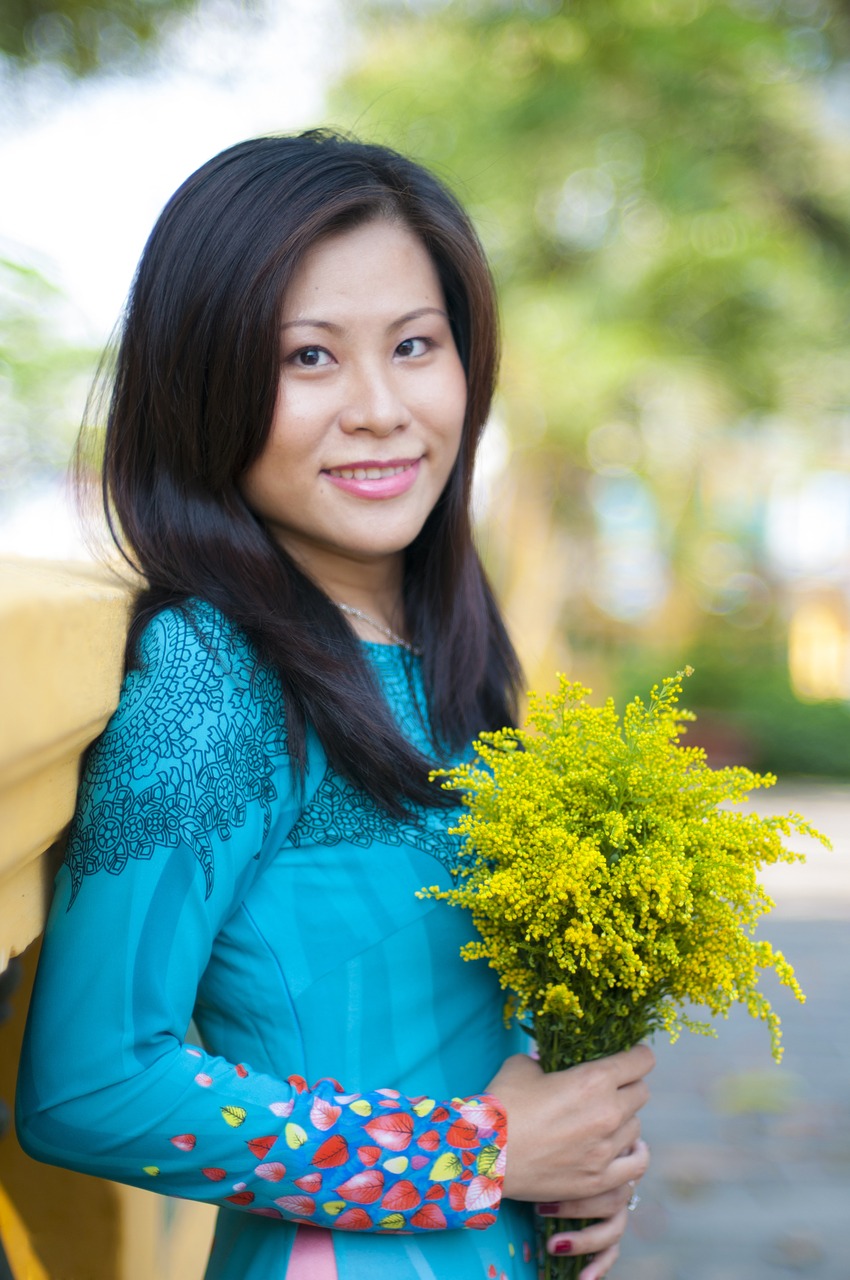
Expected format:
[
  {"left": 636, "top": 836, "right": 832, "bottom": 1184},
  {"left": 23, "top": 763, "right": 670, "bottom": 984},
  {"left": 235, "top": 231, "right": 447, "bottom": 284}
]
[{"left": 0, "top": 10, "right": 850, "bottom": 1280}]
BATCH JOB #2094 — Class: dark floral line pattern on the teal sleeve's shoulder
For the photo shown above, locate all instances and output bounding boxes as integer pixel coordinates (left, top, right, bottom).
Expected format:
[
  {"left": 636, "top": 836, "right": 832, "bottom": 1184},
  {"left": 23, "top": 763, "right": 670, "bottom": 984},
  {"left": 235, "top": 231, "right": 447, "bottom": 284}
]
[{"left": 65, "top": 604, "right": 285, "bottom": 905}]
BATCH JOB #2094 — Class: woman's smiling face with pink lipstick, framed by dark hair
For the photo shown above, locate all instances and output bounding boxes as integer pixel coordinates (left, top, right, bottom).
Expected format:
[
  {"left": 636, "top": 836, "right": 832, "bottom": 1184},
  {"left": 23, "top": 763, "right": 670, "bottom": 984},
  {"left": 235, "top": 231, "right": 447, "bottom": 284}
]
[{"left": 242, "top": 219, "right": 466, "bottom": 590}]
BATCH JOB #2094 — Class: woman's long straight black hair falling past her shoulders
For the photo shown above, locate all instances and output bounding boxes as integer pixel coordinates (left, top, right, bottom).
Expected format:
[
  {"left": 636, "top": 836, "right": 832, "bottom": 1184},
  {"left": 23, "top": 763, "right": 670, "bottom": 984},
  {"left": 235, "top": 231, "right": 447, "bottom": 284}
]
[{"left": 92, "top": 131, "right": 518, "bottom": 814}]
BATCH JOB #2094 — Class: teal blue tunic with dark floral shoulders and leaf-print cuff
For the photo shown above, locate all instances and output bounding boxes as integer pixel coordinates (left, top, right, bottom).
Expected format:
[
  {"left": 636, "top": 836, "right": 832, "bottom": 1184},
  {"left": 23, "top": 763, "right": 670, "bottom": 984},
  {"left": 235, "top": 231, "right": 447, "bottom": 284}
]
[{"left": 18, "top": 604, "right": 536, "bottom": 1280}]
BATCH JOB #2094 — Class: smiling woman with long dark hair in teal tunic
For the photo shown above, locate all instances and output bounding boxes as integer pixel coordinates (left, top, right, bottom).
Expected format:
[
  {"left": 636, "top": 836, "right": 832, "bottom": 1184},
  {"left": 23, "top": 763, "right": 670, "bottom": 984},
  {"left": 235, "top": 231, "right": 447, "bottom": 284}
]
[{"left": 18, "top": 133, "right": 652, "bottom": 1280}]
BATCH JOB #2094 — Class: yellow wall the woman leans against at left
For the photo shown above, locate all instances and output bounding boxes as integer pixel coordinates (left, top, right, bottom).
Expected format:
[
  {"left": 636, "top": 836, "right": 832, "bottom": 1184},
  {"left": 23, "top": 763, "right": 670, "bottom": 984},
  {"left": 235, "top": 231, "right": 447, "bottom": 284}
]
[{"left": 0, "top": 559, "right": 214, "bottom": 1280}]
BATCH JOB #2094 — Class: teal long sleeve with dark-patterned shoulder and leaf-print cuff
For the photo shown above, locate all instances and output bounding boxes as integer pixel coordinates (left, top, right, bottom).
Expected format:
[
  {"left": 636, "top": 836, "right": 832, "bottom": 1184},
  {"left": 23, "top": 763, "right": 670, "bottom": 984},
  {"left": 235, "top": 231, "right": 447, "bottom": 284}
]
[{"left": 17, "top": 605, "right": 506, "bottom": 1233}]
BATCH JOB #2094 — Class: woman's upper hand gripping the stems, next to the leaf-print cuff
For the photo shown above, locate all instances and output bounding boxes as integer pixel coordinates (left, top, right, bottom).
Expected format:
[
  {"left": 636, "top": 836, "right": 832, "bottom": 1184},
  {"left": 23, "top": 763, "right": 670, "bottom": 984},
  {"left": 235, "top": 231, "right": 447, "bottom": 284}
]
[{"left": 488, "top": 1044, "right": 655, "bottom": 1203}]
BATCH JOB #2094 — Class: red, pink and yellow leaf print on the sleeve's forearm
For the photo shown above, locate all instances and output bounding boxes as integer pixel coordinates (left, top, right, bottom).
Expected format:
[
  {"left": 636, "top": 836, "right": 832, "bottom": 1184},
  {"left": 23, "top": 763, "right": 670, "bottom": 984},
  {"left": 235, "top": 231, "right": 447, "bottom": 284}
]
[{"left": 157, "top": 1066, "right": 506, "bottom": 1233}]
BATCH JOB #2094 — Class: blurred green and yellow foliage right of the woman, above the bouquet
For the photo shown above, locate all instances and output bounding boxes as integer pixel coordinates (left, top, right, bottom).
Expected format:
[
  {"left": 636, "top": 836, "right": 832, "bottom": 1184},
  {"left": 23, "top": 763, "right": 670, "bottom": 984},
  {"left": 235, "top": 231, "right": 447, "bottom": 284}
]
[{"left": 333, "top": 0, "right": 850, "bottom": 776}]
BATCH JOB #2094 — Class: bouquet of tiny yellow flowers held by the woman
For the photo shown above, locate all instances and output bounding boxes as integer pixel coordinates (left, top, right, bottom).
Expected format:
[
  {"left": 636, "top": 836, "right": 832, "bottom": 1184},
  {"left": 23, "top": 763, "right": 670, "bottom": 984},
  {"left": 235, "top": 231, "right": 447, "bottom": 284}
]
[{"left": 424, "top": 668, "right": 828, "bottom": 1280}]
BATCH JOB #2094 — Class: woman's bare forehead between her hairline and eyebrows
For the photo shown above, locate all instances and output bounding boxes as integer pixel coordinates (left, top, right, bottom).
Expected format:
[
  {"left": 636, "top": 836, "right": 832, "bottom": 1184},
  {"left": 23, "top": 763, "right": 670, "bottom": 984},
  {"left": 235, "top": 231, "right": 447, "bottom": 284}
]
[{"left": 283, "top": 218, "right": 445, "bottom": 321}]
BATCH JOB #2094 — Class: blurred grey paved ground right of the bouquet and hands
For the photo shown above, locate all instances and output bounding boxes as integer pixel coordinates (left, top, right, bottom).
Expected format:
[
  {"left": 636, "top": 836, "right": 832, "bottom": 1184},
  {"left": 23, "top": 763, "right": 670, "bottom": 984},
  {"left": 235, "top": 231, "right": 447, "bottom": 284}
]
[{"left": 612, "top": 785, "right": 850, "bottom": 1280}]
